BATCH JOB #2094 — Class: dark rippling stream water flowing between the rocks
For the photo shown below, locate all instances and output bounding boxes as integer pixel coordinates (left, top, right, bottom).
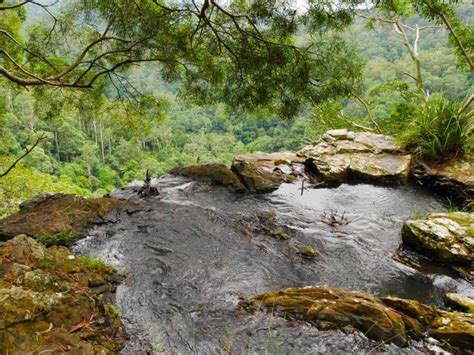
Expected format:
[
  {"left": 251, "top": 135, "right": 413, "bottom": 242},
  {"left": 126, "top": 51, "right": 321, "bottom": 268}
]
[{"left": 75, "top": 176, "right": 474, "bottom": 354}]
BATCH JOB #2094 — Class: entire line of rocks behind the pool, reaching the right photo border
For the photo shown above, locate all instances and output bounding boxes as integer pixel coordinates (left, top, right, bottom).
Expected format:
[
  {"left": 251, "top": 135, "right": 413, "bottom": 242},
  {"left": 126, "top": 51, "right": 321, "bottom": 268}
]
[{"left": 171, "top": 129, "right": 474, "bottom": 204}]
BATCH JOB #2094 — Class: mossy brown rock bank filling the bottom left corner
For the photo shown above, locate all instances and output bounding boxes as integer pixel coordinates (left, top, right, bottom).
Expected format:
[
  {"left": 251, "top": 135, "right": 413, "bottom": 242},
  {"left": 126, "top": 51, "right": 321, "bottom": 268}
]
[{"left": 0, "top": 235, "right": 126, "bottom": 354}]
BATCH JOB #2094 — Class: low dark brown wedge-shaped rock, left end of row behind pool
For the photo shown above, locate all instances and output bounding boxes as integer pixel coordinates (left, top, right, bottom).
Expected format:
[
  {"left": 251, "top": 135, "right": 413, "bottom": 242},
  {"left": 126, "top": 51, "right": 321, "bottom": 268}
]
[{"left": 170, "top": 164, "right": 246, "bottom": 192}]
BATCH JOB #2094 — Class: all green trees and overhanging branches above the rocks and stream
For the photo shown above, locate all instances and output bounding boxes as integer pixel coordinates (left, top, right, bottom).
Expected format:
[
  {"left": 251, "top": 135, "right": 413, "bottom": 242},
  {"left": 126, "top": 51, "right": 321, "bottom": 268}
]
[{"left": 0, "top": 0, "right": 474, "bottom": 214}]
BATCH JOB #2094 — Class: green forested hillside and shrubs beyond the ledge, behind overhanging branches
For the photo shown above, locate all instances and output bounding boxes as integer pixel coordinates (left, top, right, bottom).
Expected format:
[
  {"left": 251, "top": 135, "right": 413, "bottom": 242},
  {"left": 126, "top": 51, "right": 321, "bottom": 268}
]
[{"left": 0, "top": 2, "right": 474, "bottom": 216}]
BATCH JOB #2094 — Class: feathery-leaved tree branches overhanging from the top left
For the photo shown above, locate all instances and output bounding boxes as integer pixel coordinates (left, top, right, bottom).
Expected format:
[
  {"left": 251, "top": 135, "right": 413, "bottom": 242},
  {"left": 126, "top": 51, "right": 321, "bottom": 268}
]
[{"left": 0, "top": 0, "right": 363, "bottom": 116}]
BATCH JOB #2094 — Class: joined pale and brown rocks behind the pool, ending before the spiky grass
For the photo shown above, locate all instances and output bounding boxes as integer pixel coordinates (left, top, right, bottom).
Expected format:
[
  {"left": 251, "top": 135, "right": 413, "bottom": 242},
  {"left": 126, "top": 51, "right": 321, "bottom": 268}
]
[{"left": 171, "top": 130, "right": 411, "bottom": 192}]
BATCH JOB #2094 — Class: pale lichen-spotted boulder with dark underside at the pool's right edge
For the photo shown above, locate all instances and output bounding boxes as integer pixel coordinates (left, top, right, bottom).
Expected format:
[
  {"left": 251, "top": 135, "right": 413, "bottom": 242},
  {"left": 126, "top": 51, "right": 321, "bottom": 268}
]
[{"left": 402, "top": 212, "right": 474, "bottom": 269}]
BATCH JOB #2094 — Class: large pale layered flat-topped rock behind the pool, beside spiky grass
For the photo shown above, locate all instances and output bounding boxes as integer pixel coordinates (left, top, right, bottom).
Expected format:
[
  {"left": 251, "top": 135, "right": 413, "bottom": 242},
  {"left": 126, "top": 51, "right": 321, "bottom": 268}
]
[{"left": 298, "top": 129, "right": 411, "bottom": 183}]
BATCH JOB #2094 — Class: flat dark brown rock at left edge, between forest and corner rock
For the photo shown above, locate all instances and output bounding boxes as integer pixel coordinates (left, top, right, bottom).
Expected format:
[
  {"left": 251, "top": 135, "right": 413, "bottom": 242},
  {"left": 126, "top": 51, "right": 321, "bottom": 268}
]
[{"left": 0, "top": 194, "right": 123, "bottom": 245}]
